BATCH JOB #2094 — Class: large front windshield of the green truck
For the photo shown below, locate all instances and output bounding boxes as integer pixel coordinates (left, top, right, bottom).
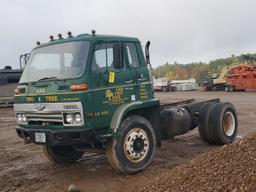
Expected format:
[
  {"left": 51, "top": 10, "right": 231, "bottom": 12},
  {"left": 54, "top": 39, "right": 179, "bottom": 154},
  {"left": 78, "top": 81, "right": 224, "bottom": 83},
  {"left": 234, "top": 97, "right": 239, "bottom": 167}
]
[{"left": 20, "top": 41, "right": 90, "bottom": 83}]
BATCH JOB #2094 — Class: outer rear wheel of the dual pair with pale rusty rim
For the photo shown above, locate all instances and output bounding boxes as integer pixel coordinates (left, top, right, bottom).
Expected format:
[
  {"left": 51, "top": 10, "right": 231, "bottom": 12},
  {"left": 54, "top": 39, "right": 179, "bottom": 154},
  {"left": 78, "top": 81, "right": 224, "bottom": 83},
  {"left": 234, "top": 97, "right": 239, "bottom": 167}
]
[{"left": 210, "top": 102, "right": 238, "bottom": 145}]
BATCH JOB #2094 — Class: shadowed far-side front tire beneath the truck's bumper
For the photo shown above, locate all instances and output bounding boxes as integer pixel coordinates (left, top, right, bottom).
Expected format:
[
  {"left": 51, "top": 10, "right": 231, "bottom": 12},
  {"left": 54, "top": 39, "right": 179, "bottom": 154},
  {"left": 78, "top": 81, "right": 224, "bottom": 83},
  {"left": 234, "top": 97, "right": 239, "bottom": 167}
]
[{"left": 43, "top": 145, "right": 84, "bottom": 164}]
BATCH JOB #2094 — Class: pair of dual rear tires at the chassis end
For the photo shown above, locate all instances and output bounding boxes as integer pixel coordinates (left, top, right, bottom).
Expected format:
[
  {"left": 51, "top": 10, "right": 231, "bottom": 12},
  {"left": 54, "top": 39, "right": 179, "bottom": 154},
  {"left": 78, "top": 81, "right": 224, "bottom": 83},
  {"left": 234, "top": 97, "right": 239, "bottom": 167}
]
[{"left": 198, "top": 102, "right": 238, "bottom": 145}]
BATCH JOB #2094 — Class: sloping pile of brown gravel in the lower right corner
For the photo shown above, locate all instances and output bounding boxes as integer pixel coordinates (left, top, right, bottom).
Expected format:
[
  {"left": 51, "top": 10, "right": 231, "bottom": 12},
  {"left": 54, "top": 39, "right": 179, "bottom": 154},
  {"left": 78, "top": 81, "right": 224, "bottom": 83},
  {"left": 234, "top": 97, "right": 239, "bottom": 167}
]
[{"left": 140, "top": 133, "right": 256, "bottom": 192}]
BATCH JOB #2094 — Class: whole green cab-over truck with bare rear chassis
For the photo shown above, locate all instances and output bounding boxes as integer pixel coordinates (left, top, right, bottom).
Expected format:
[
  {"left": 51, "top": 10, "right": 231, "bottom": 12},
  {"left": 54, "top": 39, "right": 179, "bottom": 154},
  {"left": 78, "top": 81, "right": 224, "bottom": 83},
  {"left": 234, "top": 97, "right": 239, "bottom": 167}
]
[{"left": 14, "top": 31, "right": 238, "bottom": 174}]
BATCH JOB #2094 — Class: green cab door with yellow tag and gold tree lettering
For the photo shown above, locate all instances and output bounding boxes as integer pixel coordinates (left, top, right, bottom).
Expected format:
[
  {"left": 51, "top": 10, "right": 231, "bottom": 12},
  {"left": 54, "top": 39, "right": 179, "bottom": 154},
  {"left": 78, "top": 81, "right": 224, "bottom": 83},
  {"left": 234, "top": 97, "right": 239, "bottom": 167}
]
[{"left": 91, "top": 42, "right": 135, "bottom": 128}]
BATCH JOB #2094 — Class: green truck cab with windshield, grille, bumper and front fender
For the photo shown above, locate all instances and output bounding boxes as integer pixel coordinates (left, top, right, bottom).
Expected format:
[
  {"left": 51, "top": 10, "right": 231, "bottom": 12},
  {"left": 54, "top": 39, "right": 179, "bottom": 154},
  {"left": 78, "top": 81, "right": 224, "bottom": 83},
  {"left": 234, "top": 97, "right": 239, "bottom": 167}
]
[{"left": 14, "top": 33, "right": 160, "bottom": 172}]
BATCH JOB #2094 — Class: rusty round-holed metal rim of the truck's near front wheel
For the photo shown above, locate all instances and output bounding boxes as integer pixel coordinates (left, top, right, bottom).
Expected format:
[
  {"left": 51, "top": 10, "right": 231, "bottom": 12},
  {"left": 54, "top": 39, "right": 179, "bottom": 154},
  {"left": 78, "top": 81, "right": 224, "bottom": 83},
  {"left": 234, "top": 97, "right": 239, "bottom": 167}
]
[{"left": 124, "top": 128, "right": 149, "bottom": 162}]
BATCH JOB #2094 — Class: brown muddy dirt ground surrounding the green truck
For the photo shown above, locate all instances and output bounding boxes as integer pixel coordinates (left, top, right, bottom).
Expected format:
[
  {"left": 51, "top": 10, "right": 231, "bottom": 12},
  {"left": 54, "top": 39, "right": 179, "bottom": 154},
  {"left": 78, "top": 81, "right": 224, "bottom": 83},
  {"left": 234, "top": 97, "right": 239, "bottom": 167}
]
[{"left": 0, "top": 91, "right": 256, "bottom": 192}]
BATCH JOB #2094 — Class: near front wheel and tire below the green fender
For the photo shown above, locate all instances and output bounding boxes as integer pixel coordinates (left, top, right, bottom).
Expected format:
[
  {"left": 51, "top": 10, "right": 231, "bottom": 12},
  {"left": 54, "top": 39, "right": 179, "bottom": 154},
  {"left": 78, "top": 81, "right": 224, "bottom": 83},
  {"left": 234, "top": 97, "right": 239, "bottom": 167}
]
[{"left": 106, "top": 115, "right": 156, "bottom": 174}]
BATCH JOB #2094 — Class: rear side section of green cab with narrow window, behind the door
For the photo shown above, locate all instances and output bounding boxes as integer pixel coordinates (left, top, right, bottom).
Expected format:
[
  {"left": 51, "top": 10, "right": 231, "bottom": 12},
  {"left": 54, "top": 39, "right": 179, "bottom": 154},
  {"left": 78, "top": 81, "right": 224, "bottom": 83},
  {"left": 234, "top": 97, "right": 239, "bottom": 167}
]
[{"left": 124, "top": 42, "right": 153, "bottom": 100}]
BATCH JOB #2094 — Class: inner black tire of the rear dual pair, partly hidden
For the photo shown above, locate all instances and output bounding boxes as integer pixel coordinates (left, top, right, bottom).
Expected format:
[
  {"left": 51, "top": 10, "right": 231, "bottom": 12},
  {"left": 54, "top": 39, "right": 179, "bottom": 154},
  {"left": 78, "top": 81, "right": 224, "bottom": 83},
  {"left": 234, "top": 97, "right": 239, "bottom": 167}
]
[{"left": 198, "top": 103, "right": 216, "bottom": 145}]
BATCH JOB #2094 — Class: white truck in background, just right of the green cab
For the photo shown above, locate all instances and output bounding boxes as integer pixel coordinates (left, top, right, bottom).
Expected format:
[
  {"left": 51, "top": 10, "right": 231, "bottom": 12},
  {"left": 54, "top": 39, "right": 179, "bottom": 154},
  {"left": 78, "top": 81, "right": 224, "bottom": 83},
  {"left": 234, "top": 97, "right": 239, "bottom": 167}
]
[{"left": 153, "top": 77, "right": 177, "bottom": 92}]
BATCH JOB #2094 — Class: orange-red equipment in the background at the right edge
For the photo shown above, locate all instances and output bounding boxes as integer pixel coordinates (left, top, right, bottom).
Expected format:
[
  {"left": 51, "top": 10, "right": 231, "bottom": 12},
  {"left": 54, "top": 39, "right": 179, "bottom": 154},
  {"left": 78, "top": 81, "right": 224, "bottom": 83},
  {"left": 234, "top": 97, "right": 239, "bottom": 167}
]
[{"left": 225, "top": 64, "right": 256, "bottom": 91}]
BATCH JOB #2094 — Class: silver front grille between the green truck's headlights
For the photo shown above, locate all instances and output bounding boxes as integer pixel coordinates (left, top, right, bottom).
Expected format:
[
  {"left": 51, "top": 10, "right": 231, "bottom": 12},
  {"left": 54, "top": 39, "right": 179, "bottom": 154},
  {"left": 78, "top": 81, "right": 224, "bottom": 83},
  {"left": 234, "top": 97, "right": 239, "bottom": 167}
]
[{"left": 27, "top": 112, "right": 63, "bottom": 125}]
